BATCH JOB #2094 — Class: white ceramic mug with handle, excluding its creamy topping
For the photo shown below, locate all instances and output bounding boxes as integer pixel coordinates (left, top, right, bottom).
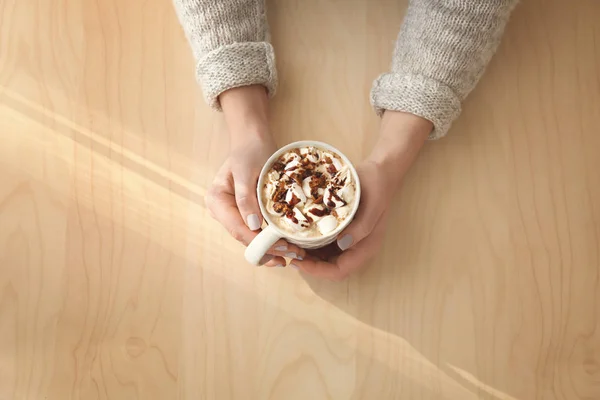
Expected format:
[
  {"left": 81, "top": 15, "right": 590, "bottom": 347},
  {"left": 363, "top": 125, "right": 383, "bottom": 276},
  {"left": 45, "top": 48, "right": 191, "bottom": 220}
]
[{"left": 244, "top": 140, "right": 360, "bottom": 265}]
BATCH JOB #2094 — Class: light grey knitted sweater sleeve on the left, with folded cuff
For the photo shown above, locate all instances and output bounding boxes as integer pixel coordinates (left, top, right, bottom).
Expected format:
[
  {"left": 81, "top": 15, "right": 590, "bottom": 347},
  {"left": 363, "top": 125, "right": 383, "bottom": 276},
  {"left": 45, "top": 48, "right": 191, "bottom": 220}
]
[{"left": 174, "top": 0, "right": 277, "bottom": 110}]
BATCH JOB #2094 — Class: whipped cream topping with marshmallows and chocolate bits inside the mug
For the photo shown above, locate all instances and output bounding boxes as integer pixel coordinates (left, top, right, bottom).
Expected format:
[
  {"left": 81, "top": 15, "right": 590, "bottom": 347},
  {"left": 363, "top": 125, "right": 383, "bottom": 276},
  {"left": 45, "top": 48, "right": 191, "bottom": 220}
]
[{"left": 262, "top": 147, "right": 356, "bottom": 237}]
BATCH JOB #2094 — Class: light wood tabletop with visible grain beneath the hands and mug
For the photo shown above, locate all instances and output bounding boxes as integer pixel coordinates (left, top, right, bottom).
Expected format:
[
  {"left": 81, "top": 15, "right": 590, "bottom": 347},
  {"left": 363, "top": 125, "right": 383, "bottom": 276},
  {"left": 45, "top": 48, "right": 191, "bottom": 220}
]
[{"left": 0, "top": 0, "right": 600, "bottom": 400}]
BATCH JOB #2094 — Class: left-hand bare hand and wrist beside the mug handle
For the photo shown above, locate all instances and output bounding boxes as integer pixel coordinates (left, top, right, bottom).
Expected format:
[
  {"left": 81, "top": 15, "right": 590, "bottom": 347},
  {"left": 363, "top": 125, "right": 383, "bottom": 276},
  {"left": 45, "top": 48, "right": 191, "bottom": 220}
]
[{"left": 206, "top": 86, "right": 305, "bottom": 267}]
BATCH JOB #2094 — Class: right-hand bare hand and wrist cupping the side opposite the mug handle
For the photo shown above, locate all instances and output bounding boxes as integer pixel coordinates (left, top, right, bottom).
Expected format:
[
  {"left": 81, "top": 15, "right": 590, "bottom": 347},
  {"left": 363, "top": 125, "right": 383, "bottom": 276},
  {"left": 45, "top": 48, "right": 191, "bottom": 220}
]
[{"left": 292, "top": 111, "right": 432, "bottom": 281}]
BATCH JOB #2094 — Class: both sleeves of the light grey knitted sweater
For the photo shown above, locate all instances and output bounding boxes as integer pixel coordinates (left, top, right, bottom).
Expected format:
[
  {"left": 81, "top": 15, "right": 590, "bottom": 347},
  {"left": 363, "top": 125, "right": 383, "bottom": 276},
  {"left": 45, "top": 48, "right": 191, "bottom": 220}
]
[{"left": 174, "top": 0, "right": 517, "bottom": 139}]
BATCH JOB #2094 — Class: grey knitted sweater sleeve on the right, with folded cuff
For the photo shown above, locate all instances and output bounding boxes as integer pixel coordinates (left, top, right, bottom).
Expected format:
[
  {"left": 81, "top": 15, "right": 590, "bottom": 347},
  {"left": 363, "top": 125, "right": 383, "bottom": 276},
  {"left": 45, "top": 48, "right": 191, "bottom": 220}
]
[{"left": 371, "top": 0, "right": 516, "bottom": 138}]
